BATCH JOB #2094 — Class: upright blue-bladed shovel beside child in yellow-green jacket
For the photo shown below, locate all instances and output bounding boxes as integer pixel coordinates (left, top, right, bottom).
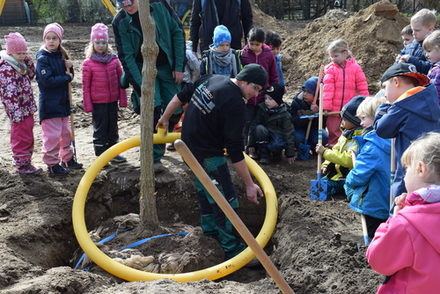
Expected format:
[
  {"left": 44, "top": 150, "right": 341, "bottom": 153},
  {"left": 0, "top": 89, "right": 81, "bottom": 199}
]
[{"left": 310, "top": 65, "right": 327, "bottom": 200}]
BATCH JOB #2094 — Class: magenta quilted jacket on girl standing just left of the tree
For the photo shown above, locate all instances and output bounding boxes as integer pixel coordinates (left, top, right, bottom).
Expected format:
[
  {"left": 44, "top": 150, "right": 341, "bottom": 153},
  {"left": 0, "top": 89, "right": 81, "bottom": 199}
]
[{"left": 82, "top": 55, "right": 127, "bottom": 112}]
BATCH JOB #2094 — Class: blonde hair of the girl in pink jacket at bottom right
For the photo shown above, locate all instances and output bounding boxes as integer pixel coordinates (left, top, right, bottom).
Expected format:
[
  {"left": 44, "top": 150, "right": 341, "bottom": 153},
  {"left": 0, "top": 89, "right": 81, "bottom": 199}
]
[{"left": 401, "top": 132, "right": 440, "bottom": 184}]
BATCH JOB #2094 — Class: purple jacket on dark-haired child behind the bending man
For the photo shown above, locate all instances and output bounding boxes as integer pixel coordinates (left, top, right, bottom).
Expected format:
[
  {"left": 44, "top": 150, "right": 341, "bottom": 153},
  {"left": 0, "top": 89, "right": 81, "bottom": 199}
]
[{"left": 240, "top": 44, "right": 278, "bottom": 106}]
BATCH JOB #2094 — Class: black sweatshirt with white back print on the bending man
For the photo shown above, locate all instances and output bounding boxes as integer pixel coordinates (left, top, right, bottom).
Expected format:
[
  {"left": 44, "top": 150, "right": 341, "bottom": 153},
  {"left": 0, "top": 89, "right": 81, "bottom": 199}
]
[{"left": 177, "top": 75, "right": 245, "bottom": 162}]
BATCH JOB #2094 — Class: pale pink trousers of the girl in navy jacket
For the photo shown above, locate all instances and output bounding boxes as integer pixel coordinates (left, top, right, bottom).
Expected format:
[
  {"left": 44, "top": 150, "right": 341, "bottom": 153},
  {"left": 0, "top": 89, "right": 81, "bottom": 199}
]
[{"left": 41, "top": 116, "right": 73, "bottom": 166}]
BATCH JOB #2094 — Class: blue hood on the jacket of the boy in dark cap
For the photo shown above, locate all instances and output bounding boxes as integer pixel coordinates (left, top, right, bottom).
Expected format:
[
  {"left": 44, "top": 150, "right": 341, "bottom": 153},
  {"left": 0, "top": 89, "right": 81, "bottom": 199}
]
[{"left": 394, "top": 84, "right": 440, "bottom": 122}]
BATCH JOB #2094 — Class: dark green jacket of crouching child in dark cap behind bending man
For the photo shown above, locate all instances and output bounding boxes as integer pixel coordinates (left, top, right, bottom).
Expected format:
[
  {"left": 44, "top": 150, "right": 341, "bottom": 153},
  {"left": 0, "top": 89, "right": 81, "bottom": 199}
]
[{"left": 249, "top": 102, "right": 295, "bottom": 157}]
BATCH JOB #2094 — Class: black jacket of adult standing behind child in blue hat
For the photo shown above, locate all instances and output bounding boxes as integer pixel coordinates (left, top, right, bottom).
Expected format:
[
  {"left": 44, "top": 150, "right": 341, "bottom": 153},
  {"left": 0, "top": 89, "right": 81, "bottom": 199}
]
[{"left": 190, "top": 0, "right": 252, "bottom": 52}]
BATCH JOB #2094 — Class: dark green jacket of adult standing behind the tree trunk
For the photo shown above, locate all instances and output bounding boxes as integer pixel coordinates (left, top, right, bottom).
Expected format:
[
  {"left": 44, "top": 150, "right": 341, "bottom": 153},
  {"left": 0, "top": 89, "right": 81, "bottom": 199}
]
[{"left": 112, "top": 0, "right": 185, "bottom": 94}]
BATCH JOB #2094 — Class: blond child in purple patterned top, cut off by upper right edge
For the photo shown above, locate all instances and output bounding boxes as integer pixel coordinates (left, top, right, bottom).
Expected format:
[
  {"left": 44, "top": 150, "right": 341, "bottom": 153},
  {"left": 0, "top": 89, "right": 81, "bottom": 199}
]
[{"left": 423, "top": 30, "right": 440, "bottom": 103}]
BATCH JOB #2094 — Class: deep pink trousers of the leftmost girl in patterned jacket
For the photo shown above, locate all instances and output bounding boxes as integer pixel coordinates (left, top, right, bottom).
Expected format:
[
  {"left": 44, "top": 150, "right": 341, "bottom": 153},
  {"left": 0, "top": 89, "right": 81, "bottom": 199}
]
[{"left": 10, "top": 115, "right": 34, "bottom": 168}]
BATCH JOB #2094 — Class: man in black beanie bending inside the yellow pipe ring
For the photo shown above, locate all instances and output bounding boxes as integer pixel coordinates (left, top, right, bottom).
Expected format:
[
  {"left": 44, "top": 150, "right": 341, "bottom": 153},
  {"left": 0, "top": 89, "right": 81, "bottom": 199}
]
[{"left": 156, "top": 64, "right": 266, "bottom": 259}]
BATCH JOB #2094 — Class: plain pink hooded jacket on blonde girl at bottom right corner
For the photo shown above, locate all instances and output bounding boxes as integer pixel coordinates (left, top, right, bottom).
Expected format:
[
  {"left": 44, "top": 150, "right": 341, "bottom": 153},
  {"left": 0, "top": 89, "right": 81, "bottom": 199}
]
[{"left": 367, "top": 202, "right": 440, "bottom": 294}]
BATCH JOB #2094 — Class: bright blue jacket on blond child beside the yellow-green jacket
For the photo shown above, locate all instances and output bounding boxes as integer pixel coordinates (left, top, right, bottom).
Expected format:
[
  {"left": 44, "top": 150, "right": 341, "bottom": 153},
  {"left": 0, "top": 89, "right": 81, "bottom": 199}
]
[{"left": 344, "top": 130, "right": 391, "bottom": 219}]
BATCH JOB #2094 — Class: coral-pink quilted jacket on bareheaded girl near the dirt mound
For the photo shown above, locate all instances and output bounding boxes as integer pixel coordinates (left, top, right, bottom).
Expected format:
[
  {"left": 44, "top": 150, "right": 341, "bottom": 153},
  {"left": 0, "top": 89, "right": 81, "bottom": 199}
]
[{"left": 322, "top": 57, "right": 369, "bottom": 111}]
